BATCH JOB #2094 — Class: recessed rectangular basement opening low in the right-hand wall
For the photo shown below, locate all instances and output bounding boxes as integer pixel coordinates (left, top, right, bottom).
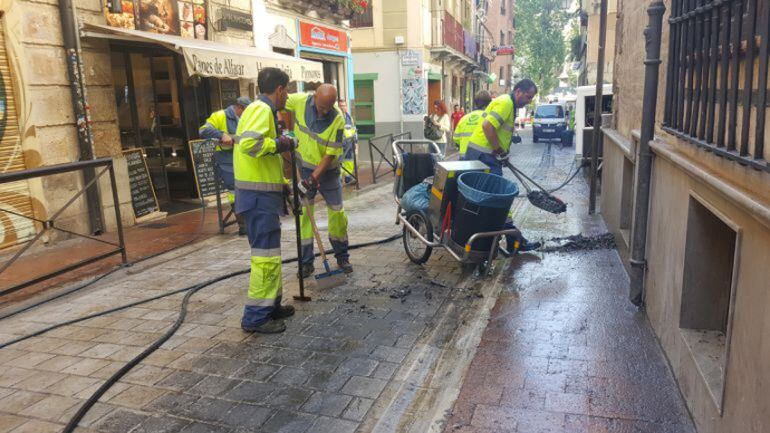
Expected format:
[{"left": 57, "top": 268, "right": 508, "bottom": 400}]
[{"left": 679, "top": 197, "right": 738, "bottom": 408}]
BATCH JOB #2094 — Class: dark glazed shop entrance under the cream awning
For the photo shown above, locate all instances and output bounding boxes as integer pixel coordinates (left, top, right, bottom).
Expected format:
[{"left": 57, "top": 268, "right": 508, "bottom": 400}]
[{"left": 111, "top": 44, "right": 198, "bottom": 213}]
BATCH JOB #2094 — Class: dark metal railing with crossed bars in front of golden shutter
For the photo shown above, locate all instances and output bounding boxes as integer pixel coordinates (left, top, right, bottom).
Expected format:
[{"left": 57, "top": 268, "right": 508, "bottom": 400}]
[{"left": 0, "top": 158, "right": 128, "bottom": 296}]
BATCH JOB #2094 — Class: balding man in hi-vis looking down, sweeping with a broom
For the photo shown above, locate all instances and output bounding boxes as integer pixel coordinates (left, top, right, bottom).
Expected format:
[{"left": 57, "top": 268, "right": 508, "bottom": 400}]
[{"left": 286, "top": 84, "right": 353, "bottom": 277}]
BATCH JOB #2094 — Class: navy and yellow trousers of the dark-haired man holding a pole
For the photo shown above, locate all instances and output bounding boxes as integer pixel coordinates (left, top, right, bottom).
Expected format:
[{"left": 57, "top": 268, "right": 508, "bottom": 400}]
[{"left": 241, "top": 192, "right": 283, "bottom": 327}]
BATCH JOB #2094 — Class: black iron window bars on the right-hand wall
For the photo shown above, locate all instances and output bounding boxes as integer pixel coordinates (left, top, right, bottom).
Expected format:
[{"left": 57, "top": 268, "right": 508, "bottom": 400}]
[{"left": 660, "top": 0, "right": 770, "bottom": 171}]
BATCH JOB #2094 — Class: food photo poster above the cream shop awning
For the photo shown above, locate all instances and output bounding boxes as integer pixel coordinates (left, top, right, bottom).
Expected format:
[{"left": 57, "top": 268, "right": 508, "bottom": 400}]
[{"left": 104, "top": 0, "right": 207, "bottom": 39}]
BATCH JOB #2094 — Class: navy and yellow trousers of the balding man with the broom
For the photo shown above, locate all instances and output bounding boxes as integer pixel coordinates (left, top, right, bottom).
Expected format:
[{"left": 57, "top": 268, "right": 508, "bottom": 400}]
[{"left": 300, "top": 168, "right": 350, "bottom": 263}]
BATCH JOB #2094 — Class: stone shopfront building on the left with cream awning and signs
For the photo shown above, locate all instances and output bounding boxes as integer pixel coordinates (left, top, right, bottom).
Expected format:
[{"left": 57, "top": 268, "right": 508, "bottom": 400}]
[{"left": 0, "top": 0, "right": 332, "bottom": 247}]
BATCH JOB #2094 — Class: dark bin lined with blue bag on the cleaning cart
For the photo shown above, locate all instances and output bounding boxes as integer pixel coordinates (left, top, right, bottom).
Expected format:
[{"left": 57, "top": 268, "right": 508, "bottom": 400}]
[{"left": 452, "top": 172, "right": 519, "bottom": 251}]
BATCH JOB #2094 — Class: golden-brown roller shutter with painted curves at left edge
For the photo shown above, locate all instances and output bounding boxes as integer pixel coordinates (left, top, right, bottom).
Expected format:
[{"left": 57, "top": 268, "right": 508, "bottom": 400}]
[{"left": 0, "top": 18, "right": 35, "bottom": 248}]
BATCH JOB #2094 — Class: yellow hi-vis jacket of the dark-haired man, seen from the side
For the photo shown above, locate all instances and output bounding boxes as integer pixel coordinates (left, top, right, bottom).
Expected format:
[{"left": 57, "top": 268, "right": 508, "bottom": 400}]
[{"left": 233, "top": 101, "right": 284, "bottom": 192}]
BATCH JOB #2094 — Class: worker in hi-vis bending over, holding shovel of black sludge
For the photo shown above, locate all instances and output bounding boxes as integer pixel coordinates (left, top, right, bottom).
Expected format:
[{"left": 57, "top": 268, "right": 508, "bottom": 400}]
[{"left": 464, "top": 78, "right": 541, "bottom": 253}]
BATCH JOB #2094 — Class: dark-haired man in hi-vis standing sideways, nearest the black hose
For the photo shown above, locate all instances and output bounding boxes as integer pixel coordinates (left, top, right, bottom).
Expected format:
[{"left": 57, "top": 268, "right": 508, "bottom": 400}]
[{"left": 233, "top": 68, "right": 295, "bottom": 334}]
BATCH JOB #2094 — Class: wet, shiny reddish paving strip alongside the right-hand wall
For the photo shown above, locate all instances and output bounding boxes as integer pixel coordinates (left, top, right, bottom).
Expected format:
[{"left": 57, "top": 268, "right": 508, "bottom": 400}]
[{"left": 444, "top": 130, "right": 695, "bottom": 433}]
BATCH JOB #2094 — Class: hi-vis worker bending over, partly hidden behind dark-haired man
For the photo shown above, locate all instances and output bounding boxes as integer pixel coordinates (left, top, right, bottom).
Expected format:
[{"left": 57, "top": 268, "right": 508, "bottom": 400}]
[{"left": 198, "top": 96, "right": 251, "bottom": 236}]
